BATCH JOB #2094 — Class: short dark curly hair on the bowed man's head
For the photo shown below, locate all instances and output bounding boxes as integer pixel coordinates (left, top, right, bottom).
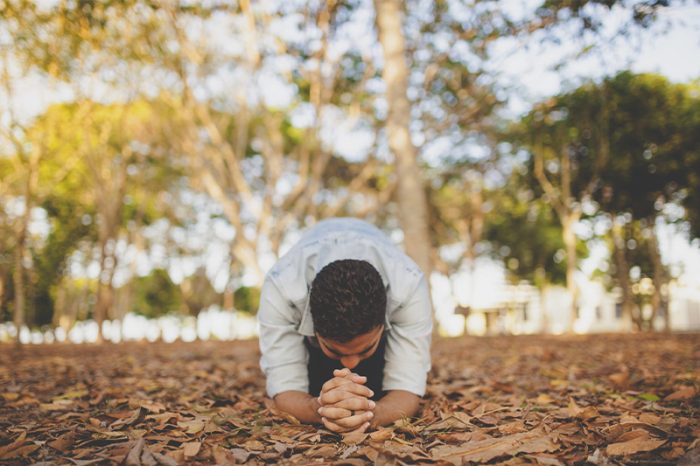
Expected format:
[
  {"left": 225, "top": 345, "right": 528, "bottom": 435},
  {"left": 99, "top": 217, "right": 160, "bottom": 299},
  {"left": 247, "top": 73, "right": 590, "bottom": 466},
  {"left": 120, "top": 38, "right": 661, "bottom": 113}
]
[{"left": 309, "top": 259, "right": 386, "bottom": 343}]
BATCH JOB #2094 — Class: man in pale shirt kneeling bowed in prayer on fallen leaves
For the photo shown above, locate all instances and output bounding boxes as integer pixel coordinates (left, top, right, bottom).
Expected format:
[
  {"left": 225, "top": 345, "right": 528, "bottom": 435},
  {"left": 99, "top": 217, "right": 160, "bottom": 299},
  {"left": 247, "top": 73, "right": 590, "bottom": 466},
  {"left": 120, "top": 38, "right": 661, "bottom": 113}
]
[{"left": 258, "top": 218, "right": 432, "bottom": 432}]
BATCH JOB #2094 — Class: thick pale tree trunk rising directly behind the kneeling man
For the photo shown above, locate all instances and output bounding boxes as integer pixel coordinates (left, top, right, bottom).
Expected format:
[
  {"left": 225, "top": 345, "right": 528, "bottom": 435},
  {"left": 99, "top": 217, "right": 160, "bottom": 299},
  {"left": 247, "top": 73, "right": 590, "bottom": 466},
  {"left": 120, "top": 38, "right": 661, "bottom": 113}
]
[{"left": 374, "top": 0, "right": 431, "bottom": 278}]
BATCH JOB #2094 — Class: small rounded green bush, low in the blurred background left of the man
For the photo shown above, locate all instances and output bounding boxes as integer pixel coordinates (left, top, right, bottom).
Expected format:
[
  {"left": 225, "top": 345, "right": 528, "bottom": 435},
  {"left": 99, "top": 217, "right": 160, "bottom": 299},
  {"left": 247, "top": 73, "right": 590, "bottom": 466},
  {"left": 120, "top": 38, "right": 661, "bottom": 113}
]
[{"left": 133, "top": 269, "right": 182, "bottom": 318}]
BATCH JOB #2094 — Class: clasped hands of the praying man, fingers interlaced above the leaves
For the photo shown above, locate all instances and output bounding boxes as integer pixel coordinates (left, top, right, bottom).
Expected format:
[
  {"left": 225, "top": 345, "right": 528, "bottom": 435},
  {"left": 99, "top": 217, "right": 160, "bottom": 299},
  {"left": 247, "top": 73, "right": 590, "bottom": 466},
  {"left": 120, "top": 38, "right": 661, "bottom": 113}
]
[{"left": 318, "top": 369, "right": 376, "bottom": 433}]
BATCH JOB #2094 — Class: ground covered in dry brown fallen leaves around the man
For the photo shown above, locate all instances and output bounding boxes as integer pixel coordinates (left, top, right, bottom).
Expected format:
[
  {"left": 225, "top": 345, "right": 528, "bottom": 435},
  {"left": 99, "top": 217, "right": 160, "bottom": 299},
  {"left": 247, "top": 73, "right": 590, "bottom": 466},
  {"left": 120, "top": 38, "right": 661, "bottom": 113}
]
[{"left": 0, "top": 334, "right": 700, "bottom": 465}]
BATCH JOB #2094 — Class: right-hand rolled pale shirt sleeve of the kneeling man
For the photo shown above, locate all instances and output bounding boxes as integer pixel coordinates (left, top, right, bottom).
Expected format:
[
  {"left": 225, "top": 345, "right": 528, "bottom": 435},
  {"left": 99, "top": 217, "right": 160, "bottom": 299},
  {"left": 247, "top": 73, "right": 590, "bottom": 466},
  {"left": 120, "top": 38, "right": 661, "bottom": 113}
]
[{"left": 382, "top": 277, "right": 433, "bottom": 396}]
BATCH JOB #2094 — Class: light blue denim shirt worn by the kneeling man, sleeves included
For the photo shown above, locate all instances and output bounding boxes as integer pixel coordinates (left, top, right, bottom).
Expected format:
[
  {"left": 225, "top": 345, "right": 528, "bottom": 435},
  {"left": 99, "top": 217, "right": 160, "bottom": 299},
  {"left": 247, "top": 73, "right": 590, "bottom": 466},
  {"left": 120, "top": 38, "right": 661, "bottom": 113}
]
[{"left": 258, "top": 218, "right": 433, "bottom": 397}]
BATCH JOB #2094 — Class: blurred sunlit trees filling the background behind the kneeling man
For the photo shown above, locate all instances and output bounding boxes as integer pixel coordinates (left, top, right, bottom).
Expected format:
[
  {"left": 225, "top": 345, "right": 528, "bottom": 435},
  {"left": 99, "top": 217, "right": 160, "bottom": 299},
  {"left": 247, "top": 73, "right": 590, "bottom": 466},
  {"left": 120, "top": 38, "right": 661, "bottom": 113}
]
[{"left": 0, "top": 0, "right": 700, "bottom": 337}]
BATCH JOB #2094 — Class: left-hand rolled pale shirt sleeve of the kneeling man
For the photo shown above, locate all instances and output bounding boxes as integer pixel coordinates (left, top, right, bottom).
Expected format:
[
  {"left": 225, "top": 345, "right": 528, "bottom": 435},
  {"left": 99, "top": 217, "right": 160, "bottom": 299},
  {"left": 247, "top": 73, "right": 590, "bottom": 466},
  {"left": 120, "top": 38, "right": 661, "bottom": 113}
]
[{"left": 258, "top": 278, "right": 309, "bottom": 398}]
